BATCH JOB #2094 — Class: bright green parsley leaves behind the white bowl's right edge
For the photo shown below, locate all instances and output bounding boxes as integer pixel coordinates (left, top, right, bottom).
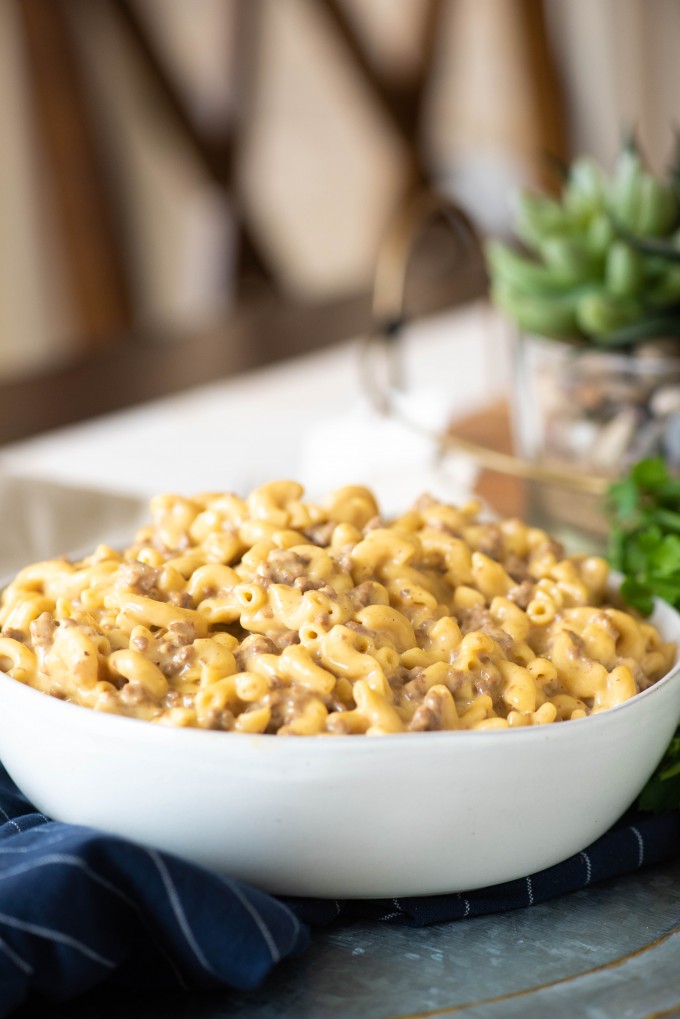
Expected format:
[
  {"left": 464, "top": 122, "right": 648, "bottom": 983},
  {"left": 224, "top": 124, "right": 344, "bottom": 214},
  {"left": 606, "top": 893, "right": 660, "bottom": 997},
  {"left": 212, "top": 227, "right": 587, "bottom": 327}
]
[{"left": 607, "top": 458, "right": 680, "bottom": 811}]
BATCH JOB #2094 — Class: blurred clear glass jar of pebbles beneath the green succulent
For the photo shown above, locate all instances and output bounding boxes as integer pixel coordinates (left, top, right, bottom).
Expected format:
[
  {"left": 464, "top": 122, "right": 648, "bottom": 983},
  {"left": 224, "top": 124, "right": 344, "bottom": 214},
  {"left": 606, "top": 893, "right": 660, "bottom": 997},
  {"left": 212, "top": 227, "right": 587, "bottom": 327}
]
[{"left": 511, "top": 333, "right": 680, "bottom": 546}]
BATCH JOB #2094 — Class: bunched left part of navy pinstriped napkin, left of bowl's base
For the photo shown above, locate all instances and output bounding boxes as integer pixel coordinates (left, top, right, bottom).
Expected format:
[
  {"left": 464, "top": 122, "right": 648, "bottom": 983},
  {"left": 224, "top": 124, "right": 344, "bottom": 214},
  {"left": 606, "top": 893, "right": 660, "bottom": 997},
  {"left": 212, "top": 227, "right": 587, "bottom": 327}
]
[{"left": 0, "top": 767, "right": 309, "bottom": 1019}]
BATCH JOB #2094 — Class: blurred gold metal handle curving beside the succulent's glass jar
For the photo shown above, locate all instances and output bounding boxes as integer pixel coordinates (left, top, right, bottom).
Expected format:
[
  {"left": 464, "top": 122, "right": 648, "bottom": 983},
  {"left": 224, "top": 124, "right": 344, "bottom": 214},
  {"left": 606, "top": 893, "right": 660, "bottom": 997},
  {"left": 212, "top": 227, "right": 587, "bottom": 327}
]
[{"left": 361, "top": 191, "right": 611, "bottom": 495}]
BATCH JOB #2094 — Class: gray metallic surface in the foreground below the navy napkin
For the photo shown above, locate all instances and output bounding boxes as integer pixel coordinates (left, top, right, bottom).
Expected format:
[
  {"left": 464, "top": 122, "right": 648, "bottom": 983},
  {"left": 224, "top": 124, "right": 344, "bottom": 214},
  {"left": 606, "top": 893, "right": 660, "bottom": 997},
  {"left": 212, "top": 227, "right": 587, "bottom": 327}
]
[{"left": 14, "top": 861, "right": 680, "bottom": 1019}]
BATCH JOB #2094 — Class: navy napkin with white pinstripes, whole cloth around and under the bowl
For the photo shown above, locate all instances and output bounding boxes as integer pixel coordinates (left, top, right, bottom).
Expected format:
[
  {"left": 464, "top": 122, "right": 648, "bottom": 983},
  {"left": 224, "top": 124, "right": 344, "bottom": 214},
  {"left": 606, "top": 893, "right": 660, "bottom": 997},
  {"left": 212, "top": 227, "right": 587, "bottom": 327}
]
[{"left": 0, "top": 767, "right": 680, "bottom": 1019}]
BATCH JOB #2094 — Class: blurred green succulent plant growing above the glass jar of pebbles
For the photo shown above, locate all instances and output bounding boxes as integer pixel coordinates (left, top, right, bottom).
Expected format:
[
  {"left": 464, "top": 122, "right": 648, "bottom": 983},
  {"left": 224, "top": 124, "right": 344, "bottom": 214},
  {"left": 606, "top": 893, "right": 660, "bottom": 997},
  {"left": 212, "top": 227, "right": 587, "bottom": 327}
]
[{"left": 486, "top": 138, "right": 680, "bottom": 347}]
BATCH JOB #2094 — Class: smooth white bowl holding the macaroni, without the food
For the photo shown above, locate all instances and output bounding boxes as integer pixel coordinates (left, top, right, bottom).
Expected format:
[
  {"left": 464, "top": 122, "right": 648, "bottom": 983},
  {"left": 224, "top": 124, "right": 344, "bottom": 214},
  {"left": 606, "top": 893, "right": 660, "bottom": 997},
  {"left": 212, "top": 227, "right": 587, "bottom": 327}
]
[{"left": 0, "top": 605, "right": 680, "bottom": 898}]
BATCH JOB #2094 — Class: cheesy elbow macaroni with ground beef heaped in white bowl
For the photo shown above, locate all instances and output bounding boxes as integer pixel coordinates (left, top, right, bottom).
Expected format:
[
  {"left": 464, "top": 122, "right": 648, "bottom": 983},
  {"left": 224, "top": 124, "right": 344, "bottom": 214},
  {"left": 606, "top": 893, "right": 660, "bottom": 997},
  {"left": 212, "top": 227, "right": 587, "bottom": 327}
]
[{"left": 0, "top": 481, "right": 675, "bottom": 735}]
